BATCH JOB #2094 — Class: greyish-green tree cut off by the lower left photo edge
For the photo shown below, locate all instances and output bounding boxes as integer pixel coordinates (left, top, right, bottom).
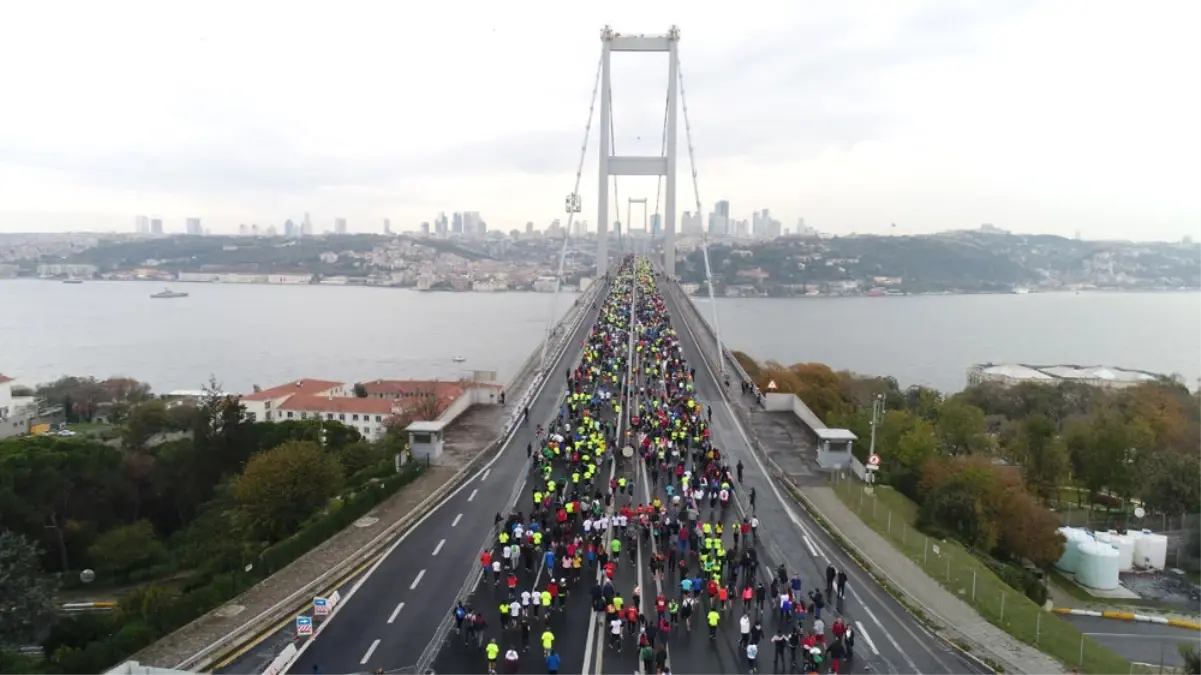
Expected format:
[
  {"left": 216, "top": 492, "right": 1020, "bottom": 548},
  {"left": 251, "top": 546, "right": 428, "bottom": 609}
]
[{"left": 0, "top": 531, "right": 54, "bottom": 647}]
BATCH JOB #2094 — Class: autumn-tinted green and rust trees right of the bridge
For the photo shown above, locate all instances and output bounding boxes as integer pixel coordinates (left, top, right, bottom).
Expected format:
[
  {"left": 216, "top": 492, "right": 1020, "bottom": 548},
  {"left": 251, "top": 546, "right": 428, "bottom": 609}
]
[{"left": 735, "top": 353, "right": 1201, "bottom": 567}]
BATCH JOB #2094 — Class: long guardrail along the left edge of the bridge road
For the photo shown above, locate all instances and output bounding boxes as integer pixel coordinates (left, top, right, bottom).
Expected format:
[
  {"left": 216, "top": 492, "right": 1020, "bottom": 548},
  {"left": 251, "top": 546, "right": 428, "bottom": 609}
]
[{"left": 174, "top": 276, "right": 607, "bottom": 670}]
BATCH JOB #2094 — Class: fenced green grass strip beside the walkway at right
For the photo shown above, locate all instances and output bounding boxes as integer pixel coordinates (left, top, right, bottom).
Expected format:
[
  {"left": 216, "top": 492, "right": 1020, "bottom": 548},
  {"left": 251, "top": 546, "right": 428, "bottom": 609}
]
[{"left": 833, "top": 478, "right": 1151, "bottom": 675}]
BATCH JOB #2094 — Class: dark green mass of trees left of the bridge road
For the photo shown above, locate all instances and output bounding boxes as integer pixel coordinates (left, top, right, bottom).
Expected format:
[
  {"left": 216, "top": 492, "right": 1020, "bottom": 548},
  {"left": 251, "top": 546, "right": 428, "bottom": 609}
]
[{"left": 0, "top": 378, "right": 419, "bottom": 675}]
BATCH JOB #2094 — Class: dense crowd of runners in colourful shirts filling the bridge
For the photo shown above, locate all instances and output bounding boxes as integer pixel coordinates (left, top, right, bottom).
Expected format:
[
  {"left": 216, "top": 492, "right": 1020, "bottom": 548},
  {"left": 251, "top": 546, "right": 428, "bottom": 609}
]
[{"left": 453, "top": 258, "right": 855, "bottom": 675}]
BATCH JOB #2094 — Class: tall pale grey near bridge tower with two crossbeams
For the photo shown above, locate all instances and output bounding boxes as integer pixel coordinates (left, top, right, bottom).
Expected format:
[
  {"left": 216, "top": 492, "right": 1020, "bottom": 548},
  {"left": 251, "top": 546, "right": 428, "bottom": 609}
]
[{"left": 597, "top": 26, "right": 680, "bottom": 277}]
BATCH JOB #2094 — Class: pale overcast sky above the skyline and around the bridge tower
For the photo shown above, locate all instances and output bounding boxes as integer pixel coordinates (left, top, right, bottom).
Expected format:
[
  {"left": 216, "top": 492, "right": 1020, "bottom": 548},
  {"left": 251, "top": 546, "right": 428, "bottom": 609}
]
[{"left": 0, "top": 0, "right": 1201, "bottom": 239}]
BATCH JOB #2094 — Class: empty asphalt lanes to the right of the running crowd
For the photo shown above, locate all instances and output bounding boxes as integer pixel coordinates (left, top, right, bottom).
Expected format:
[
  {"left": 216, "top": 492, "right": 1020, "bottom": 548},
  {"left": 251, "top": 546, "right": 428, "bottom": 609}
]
[{"left": 663, "top": 279, "right": 987, "bottom": 675}]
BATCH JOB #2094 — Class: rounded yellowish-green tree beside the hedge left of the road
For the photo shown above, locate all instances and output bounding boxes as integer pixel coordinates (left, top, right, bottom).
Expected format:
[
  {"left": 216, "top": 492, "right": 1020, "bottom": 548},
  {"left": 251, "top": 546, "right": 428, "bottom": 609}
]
[{"left": 233, "top": 441, "right": 342, "bottom": 540}]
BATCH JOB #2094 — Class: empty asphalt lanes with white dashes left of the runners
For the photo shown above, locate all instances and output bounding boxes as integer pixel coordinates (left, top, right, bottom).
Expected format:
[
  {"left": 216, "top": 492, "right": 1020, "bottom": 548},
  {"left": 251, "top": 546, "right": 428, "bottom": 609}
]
[{"left": 288, "top": 284, "right": 610, "bottom": 675}]
